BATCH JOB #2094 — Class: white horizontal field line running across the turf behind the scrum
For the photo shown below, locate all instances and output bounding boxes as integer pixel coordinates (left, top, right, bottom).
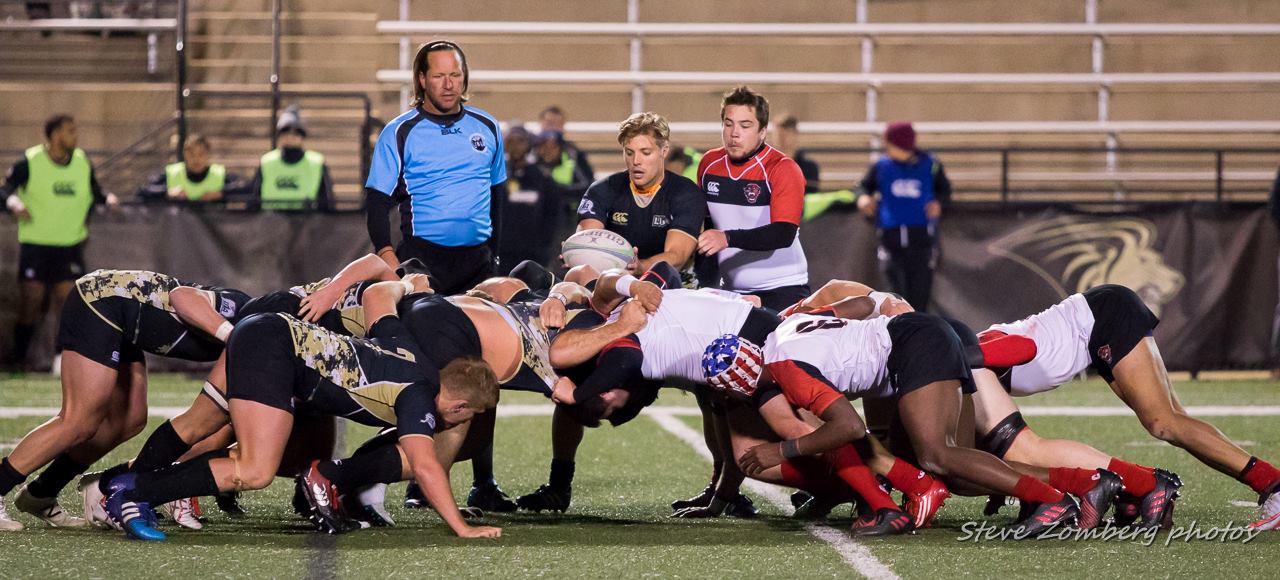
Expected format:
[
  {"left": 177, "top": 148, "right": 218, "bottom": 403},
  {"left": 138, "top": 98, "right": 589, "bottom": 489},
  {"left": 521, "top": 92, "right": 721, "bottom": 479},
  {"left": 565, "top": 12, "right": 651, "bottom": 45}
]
[{"left": 0, "top": 403, "right": 1280, "bottom": 419}]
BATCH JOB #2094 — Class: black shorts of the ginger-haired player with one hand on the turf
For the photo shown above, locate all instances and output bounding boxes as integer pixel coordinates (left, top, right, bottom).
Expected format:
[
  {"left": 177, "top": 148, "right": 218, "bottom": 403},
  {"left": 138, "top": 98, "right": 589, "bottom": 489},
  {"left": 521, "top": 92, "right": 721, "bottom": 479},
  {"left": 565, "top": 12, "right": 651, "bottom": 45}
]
[{"left": 227, "top": 314, "right": 304, "bottom": 412}]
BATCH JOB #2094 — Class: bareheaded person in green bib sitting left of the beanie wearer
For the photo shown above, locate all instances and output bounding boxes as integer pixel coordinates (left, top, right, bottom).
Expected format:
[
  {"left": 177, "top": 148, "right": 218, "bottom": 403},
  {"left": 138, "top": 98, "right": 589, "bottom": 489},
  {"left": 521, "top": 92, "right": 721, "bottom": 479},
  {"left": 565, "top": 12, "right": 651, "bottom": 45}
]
[{"left": 138, "top": 133, "right": 239, "bottom": 204}]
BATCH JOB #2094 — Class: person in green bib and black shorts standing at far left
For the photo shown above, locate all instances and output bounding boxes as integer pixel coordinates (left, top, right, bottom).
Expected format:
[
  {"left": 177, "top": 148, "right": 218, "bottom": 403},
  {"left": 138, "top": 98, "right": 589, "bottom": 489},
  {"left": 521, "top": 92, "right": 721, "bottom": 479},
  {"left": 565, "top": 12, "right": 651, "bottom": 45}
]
[{"left": 0, "top": 115, "right": 119, "bottom": 373}]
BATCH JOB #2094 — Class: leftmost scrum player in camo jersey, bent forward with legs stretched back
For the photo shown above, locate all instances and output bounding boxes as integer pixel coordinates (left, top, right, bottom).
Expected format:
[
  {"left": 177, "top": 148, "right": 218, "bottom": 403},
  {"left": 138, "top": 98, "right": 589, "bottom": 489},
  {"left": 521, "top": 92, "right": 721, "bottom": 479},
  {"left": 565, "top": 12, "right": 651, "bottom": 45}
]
[{"left": 0, "top": 270, "right": 248, "bottom": 529}]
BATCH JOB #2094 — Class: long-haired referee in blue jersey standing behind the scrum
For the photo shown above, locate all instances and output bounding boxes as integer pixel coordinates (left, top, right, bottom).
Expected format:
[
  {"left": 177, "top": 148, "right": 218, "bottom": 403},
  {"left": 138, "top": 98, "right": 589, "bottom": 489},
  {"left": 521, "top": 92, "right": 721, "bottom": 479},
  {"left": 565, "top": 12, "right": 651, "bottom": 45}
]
[{"left": 365, "top": 41, "right": 507, "bottom": 294}]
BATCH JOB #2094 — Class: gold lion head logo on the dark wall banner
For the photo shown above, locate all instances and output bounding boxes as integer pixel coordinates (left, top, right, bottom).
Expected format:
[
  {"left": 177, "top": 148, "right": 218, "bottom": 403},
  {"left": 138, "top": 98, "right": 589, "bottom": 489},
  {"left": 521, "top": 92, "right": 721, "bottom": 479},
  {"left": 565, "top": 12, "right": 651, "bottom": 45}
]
[{"left": 987, "top": 216, "right": 1187, "bottom": 316}]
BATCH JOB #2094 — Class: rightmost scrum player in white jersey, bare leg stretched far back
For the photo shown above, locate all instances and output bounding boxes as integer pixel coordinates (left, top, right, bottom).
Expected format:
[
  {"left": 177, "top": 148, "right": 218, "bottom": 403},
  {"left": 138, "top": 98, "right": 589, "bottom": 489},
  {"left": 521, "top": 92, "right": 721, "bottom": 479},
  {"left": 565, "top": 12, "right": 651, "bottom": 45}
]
[{"left": 982, "top": 284, "right": 1280, "bottom": 530}]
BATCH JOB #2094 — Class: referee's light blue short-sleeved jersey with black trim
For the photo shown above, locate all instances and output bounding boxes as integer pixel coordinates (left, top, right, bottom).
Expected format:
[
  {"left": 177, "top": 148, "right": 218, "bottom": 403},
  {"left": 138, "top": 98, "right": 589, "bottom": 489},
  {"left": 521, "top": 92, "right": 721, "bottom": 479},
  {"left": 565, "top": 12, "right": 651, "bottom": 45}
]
[{"left": 365, "top": 105, "right": 507, "bottom": 247}]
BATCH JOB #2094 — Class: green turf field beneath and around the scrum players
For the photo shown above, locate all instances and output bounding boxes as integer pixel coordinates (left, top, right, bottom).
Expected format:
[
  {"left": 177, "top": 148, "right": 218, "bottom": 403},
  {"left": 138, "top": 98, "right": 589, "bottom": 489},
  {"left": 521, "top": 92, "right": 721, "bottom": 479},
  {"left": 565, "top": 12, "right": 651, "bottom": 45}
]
[{"left": 0, "top": 375, "right": 1280, "bottom": 579}]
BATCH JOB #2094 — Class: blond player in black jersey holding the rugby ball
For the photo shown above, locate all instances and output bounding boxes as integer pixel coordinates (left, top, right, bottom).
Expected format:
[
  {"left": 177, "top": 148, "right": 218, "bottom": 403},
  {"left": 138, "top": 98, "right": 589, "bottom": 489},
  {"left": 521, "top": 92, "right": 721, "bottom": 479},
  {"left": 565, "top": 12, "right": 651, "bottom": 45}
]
[{"left": 577, "top": 113, "right": 707, "bottom": 273}]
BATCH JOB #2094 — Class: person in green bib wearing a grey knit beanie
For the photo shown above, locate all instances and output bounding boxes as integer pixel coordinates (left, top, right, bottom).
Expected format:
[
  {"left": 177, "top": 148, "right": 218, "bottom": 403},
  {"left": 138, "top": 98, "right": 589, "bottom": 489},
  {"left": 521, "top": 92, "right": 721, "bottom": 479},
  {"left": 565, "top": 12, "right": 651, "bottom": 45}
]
[{"left": 251, "top": 105, "right": 333, "bottom": 211}]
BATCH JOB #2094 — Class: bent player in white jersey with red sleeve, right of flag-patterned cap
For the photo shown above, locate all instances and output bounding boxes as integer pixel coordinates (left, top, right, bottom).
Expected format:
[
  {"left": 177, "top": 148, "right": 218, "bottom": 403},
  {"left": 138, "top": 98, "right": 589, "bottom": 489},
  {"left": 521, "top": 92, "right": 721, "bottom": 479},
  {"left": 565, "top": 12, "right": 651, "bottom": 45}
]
[{"left": 721, "top": 304, "right": 1079, "bottom": 534}]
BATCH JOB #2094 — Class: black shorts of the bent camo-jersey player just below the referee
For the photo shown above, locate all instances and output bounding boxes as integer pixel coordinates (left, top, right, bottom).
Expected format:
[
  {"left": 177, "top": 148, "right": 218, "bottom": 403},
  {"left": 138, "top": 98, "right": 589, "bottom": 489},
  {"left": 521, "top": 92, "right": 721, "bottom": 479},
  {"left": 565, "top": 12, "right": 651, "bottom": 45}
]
[{"left": 399, "top": 294, "right": 483, "bottom": 369}]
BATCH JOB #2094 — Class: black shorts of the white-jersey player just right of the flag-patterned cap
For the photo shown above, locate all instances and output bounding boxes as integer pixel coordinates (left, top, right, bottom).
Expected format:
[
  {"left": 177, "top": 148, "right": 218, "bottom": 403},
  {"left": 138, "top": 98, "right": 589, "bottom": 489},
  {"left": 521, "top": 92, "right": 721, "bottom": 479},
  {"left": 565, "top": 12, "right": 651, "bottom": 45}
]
[{"left": 888, "top": 312, "right": 977, "bottom": 397}]
